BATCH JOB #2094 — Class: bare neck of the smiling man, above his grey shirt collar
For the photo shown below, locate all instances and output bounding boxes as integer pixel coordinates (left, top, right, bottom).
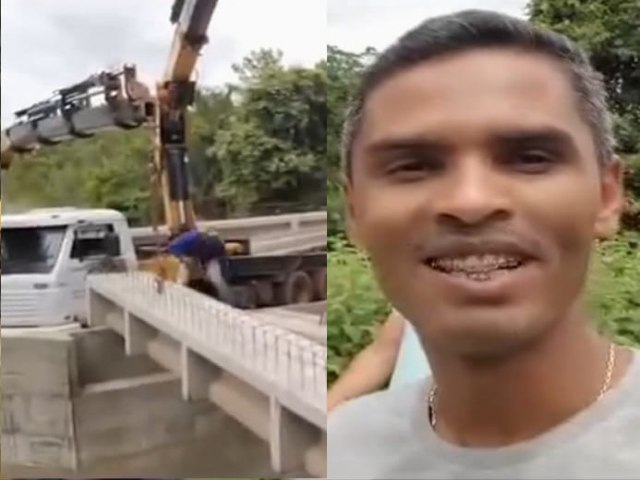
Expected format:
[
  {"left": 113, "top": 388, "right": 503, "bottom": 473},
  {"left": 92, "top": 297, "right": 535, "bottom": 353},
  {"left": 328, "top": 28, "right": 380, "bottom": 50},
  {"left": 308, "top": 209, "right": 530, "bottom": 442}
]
[{"left": 430, "top": 314, "right": 628, "bottom": 447}]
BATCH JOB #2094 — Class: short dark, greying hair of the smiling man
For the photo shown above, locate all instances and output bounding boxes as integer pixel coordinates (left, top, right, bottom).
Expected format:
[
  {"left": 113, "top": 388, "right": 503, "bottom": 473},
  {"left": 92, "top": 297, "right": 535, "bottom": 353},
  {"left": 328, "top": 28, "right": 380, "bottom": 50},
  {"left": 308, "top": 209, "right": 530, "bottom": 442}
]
[{"left": 342, "top": 10, "right": 614, "bottom": 177}]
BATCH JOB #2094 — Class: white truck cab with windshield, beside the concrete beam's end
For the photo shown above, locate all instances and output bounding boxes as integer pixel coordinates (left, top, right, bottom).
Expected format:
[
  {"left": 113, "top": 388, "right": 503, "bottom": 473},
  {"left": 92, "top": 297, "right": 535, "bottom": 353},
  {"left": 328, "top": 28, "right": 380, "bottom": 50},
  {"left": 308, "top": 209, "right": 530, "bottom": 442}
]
[{"left": 0, "top": 208, "right": 137, "bottom": 328}]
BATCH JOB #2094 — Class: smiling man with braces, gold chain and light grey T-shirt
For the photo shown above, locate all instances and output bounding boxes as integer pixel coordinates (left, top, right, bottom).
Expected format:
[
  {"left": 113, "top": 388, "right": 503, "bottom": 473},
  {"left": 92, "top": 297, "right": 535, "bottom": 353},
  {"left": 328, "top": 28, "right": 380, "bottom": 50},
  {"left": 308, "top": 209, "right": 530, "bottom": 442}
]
[{"left": 328, "top": 11, "right": 640, "bottom": 479}]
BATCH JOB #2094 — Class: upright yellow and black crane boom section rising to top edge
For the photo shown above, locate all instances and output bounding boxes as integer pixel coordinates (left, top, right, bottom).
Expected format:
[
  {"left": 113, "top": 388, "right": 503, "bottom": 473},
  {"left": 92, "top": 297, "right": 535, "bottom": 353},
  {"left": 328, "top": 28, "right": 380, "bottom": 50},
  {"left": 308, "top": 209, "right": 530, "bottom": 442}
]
[{"left": 155, "top": 0, "right": 218, "bottom": 234}]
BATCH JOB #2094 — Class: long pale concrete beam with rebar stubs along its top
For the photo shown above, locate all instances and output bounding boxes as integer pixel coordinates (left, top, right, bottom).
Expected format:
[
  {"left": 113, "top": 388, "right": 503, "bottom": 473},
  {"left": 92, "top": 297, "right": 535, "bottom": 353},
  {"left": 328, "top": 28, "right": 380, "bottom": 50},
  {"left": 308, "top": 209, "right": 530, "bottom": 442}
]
[{"left": 88, "top": 272, "right": 327, "bottom": 477}]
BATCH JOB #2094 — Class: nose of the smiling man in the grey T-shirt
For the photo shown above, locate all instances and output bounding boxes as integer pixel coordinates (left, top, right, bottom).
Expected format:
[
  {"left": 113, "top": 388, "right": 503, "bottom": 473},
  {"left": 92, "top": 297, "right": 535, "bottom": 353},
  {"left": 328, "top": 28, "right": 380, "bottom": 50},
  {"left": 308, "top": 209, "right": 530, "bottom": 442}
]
[{"left": 436, "top": 159, "right": 513, "bottom": 227}]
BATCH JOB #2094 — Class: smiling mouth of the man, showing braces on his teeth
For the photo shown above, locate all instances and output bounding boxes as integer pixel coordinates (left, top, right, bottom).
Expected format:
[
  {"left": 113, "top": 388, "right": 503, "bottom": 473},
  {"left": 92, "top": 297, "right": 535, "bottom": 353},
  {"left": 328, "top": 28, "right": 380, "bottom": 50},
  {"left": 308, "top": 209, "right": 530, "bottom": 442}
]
[{"left": 424, "top": 254, "right": 529, "bottom": 282}]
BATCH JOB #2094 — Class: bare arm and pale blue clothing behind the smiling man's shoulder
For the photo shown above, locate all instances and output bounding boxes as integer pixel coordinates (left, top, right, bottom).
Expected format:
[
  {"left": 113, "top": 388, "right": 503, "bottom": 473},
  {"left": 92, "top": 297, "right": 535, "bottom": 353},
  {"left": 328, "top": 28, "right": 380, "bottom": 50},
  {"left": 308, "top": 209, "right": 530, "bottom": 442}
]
[{"left": 327, "top": 311, "right": 429, "bottom": 413}]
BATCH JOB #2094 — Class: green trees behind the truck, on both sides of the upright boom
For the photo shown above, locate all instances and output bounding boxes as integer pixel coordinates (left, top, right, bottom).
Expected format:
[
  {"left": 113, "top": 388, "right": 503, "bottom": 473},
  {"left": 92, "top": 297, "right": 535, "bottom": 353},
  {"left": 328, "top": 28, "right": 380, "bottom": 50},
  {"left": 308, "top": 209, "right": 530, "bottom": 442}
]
[{"left": 3, "top": 49, "right": 327, "bottom": 224}]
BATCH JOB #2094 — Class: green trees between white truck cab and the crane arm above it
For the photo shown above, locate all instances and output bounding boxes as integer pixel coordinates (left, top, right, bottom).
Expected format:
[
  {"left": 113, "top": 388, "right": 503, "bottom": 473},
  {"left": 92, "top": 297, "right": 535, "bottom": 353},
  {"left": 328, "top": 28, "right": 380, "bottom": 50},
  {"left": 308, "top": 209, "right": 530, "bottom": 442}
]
[{"left": 3, "top": 131, "right": 151, "bottom": 223}]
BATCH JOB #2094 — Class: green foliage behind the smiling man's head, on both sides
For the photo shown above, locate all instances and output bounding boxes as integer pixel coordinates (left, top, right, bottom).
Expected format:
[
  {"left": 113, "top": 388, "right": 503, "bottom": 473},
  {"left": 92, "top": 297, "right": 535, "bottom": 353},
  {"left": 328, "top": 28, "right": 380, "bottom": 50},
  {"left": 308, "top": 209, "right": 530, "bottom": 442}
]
[{"left": 327, "top": 0, "right": 640, "bottom": 383}]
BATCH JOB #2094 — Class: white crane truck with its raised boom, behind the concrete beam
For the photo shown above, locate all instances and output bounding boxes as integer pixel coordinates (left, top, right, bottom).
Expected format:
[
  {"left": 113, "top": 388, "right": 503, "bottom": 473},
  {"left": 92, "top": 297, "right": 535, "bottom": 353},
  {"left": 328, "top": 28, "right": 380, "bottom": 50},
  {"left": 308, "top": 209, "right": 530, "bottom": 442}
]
[{"left": 0, "top": 0, "right": 326, "bottom": 327}]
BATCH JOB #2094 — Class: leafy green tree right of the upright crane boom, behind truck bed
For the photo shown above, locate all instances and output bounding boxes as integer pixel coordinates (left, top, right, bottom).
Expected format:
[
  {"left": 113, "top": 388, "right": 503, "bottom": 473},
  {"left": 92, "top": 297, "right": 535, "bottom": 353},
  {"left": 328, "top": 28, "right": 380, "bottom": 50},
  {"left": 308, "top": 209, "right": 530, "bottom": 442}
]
[{"left": 212, "top": 50, "right": 327, "bottom": 212}]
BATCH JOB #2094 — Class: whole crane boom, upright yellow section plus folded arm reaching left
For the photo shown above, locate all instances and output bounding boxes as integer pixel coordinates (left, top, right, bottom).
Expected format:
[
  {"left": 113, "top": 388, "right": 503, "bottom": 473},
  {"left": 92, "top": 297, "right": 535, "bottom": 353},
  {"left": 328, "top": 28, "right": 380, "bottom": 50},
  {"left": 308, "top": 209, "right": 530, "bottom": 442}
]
[{"left": 1, "top": 0, "right": 218, "bottom": 240}]
